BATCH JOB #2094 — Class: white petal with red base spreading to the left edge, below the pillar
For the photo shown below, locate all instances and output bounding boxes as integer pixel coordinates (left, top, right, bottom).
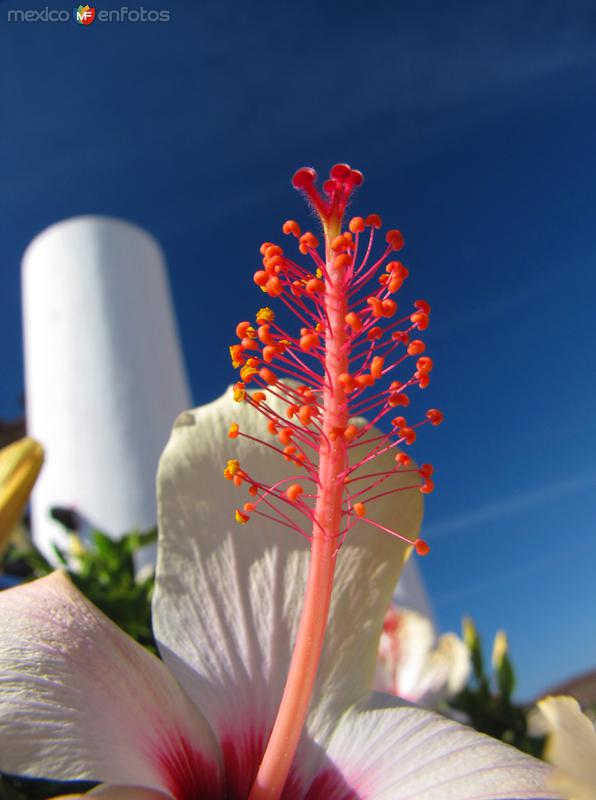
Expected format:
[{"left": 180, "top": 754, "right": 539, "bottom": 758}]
[{"left": 0, "top": 572, "right": 219, "bottom": 791}]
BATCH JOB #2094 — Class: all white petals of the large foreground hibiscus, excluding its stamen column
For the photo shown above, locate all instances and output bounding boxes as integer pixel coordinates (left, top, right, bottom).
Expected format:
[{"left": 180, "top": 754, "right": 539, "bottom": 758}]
[{"left": 0, "top": 393, "right": 557, "bottom": 800}]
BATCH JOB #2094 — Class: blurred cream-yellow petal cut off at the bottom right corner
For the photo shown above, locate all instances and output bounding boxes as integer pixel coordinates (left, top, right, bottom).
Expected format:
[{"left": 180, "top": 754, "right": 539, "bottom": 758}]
[{"left": 531, "top": 696, "right": 596, "bottom": 800}]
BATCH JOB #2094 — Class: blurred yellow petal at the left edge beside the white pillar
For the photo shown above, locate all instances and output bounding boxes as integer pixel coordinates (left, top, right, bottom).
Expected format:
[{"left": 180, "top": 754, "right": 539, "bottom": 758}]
[{"left": 0, "top": 436, "right": 44, "bottom": 552}]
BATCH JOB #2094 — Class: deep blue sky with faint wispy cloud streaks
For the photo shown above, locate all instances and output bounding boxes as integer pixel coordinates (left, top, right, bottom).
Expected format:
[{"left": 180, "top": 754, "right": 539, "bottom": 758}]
[{"left": 0, "top": 0, "right": 596, "bottom": 696}]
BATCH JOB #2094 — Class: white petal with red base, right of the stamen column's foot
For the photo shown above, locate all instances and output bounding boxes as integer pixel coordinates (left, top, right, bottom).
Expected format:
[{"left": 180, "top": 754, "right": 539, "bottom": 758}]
[{"left": 306, "top": 706, "right": 560, "bottom": 800}]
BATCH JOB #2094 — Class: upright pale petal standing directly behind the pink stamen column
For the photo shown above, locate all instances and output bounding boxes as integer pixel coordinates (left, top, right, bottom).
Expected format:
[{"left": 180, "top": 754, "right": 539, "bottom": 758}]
[{"left": 154, "top": 391, "right": 422, "bottom": 786}]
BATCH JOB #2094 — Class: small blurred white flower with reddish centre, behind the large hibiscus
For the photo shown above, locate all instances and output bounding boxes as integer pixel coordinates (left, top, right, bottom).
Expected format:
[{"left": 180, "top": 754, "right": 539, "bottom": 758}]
[{"left": 374, "top": 605, "right": 470, "bottom": 708}]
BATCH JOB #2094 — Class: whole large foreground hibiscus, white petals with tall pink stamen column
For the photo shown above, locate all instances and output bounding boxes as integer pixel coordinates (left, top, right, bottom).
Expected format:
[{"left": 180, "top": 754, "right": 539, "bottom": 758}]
[{"left": 0, "top": 164, "right": 553, "bottom": 800}]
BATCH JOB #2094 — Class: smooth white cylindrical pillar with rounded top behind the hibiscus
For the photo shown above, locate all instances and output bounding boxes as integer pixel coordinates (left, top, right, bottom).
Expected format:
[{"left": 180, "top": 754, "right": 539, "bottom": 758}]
[{"left": 23, "top": 216, "right": 191, "bottom": 559}]
